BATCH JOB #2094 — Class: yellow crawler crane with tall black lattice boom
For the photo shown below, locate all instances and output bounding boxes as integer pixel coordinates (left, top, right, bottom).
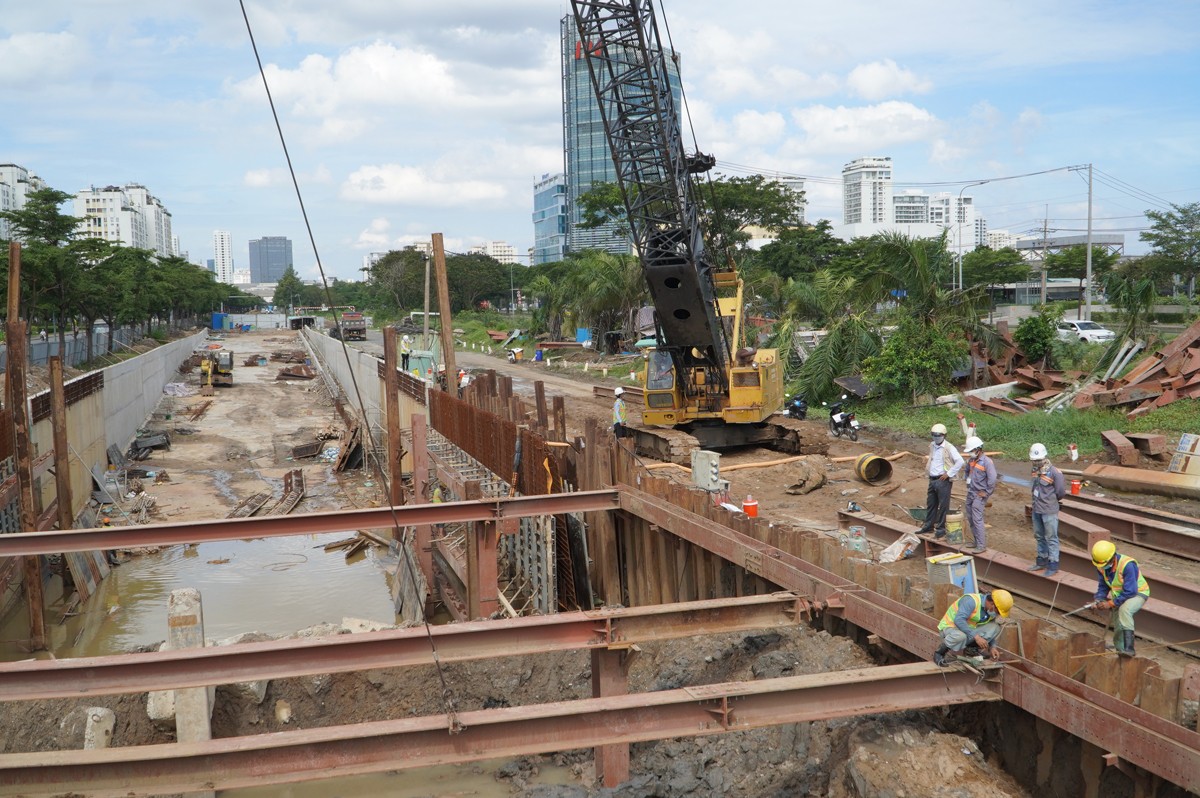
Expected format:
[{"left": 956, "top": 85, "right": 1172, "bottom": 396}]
[{"left": 571, "top": 0, "right": 817, "bottom": 462}]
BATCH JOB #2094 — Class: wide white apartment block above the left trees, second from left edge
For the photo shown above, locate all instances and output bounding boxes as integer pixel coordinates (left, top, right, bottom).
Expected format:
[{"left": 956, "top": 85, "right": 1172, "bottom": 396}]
[{"left": 74, "top": 182, "right": 175, "bottom": 258}]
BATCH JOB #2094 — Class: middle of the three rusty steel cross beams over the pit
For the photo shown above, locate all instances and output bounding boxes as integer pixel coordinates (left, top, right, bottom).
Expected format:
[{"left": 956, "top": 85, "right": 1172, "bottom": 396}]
[{"left": 0, "top": 593, "right": 810, "bottom": 701}]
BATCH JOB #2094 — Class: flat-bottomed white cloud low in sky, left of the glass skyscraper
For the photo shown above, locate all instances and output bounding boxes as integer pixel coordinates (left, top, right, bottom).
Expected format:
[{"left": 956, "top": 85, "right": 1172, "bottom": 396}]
[{"left": 341, "top": 163, "right": 508, "bottom": 208}]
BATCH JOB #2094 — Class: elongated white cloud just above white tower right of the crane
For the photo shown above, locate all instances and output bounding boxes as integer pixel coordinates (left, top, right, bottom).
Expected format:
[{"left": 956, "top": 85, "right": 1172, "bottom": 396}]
[{"left": 792, "top": 100, "right": 942, "bottom": 154}]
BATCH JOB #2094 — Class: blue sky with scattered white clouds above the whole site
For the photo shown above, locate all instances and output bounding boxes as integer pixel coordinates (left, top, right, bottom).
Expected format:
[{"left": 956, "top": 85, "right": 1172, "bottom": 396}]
[{"left": 0, "top": 0, "right": 1200, "bottom": 278}]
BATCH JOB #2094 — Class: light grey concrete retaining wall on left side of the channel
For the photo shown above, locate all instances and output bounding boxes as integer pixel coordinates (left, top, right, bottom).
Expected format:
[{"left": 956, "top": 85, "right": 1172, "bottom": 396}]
[{"left": 104, "top": 332, "right": 206, "bottom": 449}]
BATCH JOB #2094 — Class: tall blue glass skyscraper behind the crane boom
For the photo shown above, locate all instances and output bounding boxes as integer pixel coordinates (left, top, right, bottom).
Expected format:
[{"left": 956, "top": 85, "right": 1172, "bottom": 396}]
[{"left": 560, "top": 17, "right": 683, "bottom": 253}]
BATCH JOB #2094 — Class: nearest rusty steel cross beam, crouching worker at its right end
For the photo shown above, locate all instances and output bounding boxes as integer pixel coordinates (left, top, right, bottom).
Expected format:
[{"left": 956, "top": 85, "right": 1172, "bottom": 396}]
[{"left": 0, "top": 662, "right": 1000, "bottom": 798}]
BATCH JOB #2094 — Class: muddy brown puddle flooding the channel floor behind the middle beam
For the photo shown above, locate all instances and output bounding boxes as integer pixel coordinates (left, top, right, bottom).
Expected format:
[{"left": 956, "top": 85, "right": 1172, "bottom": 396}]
[{"left": 0, "top": 533, "right": 396, "bottom": 660}]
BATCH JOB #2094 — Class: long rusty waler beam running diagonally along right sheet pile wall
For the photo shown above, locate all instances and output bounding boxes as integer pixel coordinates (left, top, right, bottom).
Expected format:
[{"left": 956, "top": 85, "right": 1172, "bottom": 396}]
[{"left": 620, "top": 486, "right": 1200, "bottom": 792}]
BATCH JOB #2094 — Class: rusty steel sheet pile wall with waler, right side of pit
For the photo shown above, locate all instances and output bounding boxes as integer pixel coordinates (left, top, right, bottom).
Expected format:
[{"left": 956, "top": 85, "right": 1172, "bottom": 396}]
[{"left": 580, "top": 427, "right": 1200, "bottom": 791}]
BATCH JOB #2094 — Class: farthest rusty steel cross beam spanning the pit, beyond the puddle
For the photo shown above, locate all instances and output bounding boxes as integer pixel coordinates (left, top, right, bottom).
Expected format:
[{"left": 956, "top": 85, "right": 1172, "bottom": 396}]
[{"left": 0, "top": 490, "right": 618, "bottom": 557}]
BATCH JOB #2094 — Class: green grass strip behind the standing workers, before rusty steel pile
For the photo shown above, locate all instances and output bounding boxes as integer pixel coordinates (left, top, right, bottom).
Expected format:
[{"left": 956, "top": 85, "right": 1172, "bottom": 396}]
[{"left": 860, "top": 400, "right": 1200, "bottom": 460}]
